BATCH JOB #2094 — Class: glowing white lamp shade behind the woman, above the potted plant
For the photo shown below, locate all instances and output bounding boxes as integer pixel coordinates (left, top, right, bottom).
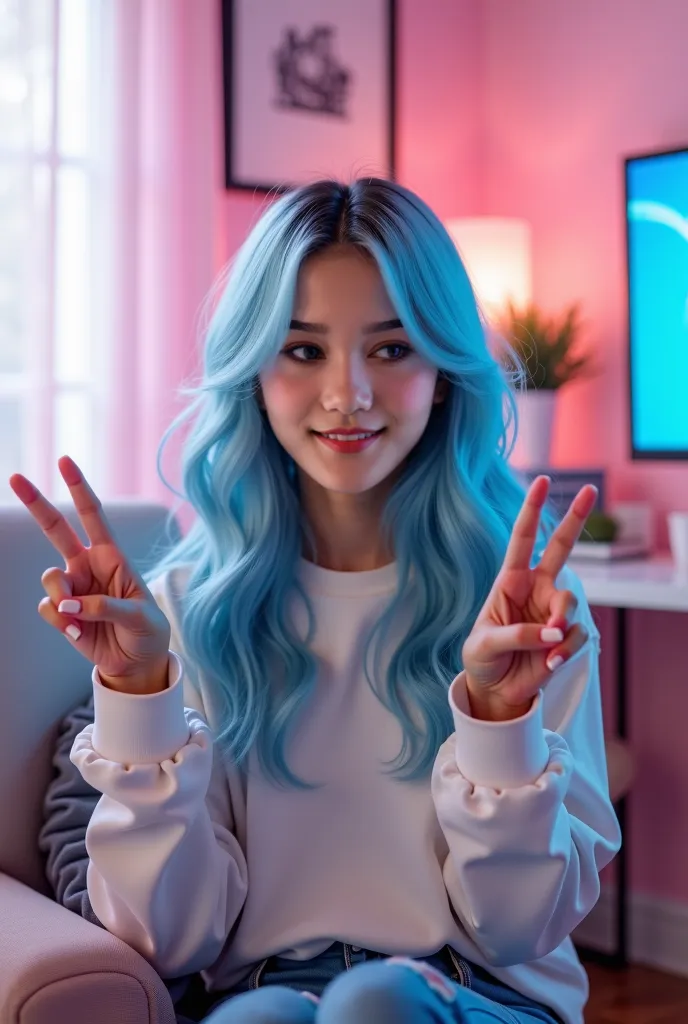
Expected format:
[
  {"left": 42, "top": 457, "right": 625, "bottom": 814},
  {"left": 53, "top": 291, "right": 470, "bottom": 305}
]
[{"left": 444, "top": 217, "right": 531, "bottom": 317}]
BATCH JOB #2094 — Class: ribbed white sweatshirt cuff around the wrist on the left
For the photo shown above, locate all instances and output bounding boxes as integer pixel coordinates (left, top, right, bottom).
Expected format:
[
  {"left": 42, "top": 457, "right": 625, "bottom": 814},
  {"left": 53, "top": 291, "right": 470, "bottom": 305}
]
[{"left": 91, "top": 650, "right": 189, "bottom": 765}]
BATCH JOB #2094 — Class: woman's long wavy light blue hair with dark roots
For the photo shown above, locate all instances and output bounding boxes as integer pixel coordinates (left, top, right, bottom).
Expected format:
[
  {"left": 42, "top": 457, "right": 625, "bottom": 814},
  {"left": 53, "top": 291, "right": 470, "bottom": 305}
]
[{"left": 144, "top": 178, "right": 554, "bottom": 788}]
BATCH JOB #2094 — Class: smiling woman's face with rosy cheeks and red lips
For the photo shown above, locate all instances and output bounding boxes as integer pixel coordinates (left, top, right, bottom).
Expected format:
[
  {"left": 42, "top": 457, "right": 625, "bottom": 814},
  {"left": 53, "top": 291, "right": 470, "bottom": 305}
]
[{"left": 259, "top": 246, "right": 446, "bottom": 503}]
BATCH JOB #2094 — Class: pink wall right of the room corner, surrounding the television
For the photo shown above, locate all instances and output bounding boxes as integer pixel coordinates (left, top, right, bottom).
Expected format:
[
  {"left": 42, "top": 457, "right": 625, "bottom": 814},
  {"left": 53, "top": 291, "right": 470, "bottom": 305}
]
[{"left": 479, "top": 0, "right": 688, "bottom": 901}]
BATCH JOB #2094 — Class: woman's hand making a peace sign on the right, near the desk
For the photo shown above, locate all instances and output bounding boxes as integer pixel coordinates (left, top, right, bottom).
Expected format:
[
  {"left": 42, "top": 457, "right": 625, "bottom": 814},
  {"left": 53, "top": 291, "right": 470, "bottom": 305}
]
[{"left": 463, "top": 476, "right": 597, "bottom": 721}]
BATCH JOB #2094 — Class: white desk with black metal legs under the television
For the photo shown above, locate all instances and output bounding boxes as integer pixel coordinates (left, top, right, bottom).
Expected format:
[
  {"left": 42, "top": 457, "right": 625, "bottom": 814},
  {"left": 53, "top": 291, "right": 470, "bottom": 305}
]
[{"left": 568, "top": 556, "right": 688, "bottom": 967}]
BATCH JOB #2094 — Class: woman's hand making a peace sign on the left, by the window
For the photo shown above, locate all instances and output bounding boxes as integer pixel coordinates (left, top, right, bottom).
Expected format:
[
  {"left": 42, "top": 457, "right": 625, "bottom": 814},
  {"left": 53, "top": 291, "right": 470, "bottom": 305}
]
[{"left": 9, "top": 456, "right": 170, "bottom": 694}]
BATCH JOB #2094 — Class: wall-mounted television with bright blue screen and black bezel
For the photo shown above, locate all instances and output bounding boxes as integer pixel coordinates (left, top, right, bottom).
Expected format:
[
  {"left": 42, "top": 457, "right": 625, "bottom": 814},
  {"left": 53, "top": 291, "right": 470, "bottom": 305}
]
[{"left": 625, "top": 146, "right": 688, "bottom": 459}]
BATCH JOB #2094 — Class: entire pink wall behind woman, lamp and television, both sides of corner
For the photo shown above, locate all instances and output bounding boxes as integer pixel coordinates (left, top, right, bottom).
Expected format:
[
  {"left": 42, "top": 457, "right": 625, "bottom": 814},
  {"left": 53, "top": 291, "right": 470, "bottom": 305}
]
[{"left": 215, "top": 0, "right": 688, "bottom": 900}]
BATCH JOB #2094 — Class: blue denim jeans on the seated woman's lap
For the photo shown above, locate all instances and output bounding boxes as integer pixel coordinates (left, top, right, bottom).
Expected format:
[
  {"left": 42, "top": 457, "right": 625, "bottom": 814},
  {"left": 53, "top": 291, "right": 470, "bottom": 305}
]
[{"left": 177, "top": 942, "right": 563, "bottom": 1024}]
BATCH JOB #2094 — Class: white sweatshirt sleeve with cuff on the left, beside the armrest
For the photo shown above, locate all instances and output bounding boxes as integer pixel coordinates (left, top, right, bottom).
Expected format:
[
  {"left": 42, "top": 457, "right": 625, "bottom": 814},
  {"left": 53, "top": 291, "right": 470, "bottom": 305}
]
[{"left": 70, "top": 573, "right": 248, "bottom": 978}]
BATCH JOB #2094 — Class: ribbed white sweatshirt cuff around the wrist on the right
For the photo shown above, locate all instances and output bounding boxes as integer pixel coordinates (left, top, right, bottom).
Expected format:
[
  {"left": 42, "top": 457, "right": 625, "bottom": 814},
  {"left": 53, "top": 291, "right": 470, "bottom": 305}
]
[{"left": 448, "top": 672, "right": 550, "bottom": 790}]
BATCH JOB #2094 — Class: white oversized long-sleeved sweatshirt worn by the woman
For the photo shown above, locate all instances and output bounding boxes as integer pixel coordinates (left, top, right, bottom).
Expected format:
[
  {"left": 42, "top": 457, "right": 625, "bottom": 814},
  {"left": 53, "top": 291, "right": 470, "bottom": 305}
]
[{"left": 70, "top": 560, "right": 620, "bottom": 1024}]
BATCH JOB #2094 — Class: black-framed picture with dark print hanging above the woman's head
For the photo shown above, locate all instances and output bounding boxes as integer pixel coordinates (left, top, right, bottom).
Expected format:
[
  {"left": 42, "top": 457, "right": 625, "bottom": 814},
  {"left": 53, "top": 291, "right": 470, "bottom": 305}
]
[{"left": 221, "top": 0, "right": 397, "bottom": 195}]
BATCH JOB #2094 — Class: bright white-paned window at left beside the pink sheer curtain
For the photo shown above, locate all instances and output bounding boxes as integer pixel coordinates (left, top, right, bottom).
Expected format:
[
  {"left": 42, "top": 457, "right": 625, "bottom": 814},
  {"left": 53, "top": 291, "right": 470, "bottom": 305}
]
[{"left": 0, "top": 0, "right": 103, "bottom": 501}]
